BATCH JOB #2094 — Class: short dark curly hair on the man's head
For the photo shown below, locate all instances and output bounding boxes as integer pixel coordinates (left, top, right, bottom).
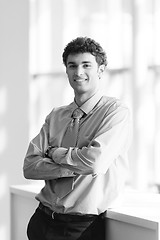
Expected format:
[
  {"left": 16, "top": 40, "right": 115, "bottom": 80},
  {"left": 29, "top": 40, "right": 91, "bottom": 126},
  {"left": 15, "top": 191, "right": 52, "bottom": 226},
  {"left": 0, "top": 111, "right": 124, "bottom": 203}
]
[{"left": 62, "top": 37, "right": 107, "bottom": 66}]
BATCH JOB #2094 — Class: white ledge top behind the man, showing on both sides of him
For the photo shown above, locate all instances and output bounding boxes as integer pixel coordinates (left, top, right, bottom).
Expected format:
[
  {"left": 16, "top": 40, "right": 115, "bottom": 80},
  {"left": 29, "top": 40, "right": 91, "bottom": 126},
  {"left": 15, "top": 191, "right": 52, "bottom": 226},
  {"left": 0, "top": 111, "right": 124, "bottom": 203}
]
[{"left": 10, "top": 184, "right": 160, "bottom": 229}]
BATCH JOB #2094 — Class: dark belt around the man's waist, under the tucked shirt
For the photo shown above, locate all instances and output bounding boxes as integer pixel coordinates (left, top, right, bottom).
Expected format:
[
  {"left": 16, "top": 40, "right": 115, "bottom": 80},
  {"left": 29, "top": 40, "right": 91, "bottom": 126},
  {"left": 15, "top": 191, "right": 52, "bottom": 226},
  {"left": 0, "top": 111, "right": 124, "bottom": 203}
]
[{"left": 38, "top": 203, "right": 98, "bottom": 222}]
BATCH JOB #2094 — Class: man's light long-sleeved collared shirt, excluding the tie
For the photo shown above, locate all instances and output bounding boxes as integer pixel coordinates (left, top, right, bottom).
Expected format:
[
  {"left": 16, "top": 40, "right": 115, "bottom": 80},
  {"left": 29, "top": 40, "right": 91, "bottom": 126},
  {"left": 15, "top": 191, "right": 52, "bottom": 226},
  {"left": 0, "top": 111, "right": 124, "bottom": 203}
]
[{"left": 23, "top": 93, "right": 131, "bottom": 214}]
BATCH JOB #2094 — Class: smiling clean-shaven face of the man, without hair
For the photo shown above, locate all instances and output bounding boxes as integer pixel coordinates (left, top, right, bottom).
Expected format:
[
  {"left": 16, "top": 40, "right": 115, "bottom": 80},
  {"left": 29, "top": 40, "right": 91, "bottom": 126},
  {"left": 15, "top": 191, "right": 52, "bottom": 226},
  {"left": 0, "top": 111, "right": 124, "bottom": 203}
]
[{"left": 66, "top": 53, "right": 103, "bottom": 97}]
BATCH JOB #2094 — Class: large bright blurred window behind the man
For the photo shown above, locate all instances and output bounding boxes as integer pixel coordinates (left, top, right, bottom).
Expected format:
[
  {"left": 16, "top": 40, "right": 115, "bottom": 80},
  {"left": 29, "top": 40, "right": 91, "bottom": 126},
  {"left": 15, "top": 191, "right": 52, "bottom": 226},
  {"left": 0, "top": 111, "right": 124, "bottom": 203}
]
[{"left": 30, "top": 0, "right": 160, "bottom": 192}]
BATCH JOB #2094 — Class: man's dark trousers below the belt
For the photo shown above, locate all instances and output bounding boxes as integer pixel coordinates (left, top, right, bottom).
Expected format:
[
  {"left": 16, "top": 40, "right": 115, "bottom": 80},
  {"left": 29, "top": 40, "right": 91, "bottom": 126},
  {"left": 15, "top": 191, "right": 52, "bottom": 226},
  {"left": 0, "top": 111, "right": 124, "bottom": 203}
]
[{"left": 27, "top": 208, "right": 106, "bottom": 240}]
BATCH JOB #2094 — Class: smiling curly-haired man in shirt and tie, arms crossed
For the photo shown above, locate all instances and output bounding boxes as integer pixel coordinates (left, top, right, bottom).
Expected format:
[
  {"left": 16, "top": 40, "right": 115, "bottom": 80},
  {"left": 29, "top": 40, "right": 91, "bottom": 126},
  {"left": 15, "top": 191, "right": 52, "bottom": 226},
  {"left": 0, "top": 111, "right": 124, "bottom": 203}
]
[{"left": 23, "top": 37, "right": 130, "bottom": 240}]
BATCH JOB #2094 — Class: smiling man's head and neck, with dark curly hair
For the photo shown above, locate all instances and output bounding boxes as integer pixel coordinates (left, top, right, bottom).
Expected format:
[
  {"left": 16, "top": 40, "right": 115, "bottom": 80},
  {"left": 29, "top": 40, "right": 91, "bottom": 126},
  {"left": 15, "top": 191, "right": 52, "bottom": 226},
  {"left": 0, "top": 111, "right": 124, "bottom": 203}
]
[{"left": 63, "top": 37, "right": 107, "bottom": 105}]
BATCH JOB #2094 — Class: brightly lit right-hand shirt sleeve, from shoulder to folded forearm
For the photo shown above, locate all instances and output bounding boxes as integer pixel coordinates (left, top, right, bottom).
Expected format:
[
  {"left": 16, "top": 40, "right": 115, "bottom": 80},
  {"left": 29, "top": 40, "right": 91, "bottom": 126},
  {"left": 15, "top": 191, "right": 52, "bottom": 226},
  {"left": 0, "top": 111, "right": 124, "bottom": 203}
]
[{"left": 52, "top": 105, "right": 131, "bottom": 175}]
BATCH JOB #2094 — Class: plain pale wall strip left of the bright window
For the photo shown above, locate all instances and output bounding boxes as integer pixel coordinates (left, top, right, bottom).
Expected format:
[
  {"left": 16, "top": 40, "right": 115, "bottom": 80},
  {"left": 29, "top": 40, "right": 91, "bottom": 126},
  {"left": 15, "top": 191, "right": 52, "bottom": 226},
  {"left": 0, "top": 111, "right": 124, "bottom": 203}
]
[{"left": 0, "top": 0, "right": 29, "bottom": 240}]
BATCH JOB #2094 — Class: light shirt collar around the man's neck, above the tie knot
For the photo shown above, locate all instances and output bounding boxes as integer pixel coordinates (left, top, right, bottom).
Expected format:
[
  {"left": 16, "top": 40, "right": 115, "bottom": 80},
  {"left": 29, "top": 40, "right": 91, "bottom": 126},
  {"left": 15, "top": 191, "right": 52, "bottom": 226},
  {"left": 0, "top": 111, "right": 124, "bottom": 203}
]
[{"left": 73, "top": 91, "right": 102, "bottom": 114}]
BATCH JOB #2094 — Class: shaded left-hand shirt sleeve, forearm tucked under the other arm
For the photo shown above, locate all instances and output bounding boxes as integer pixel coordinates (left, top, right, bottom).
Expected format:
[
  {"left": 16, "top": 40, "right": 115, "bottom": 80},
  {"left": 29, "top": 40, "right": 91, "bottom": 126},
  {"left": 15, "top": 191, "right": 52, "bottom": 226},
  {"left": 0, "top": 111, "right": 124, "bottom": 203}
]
[{"left": 23, "top": 114, "right": 74, "bottom": 180}]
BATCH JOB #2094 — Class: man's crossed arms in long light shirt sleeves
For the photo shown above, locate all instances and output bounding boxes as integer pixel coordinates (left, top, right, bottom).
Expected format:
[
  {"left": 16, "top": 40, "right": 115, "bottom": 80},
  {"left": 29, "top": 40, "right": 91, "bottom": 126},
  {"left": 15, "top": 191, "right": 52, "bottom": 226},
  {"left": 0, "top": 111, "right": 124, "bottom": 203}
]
[{"left": 23, "top": 106, "right": 131, "bottom": 180}]
